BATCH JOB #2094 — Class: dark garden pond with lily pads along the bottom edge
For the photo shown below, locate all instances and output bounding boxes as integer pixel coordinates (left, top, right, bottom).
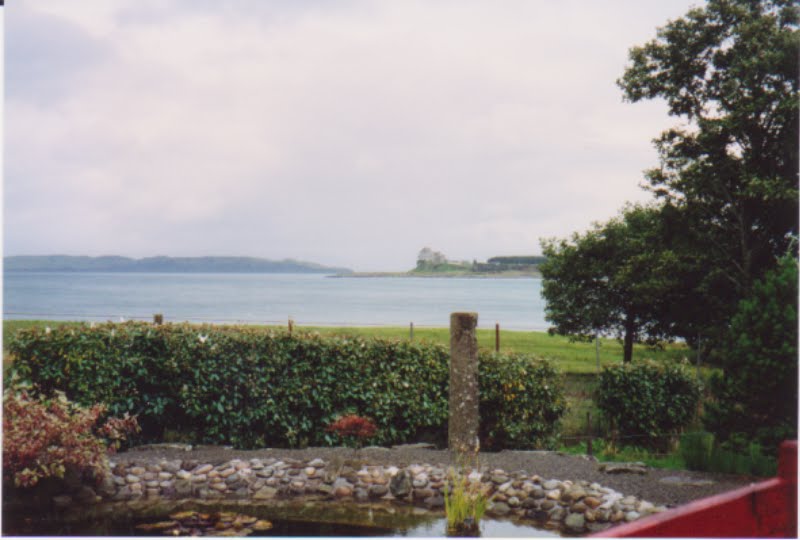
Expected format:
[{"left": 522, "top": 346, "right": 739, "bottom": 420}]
[{"left": 2, "top": 501, "right": 559, "bottom": 537}]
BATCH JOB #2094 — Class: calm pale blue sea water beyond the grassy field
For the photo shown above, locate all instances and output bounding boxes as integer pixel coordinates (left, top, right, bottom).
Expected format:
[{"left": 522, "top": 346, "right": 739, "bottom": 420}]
[{"left": 3, "top": 272, "right": 548, "bottom": 330}]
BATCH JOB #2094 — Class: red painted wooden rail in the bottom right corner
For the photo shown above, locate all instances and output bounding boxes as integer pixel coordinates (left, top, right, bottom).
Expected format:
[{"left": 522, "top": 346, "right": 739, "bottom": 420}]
[{"left": 592, "top": 441, "right": 797, "bottom": 538}]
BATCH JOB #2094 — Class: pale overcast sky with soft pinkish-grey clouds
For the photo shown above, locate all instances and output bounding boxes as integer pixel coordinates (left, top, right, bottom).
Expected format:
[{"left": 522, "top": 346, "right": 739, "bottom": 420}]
[{"left": 3, "top": 0, "right": 696, "bottom": 271}]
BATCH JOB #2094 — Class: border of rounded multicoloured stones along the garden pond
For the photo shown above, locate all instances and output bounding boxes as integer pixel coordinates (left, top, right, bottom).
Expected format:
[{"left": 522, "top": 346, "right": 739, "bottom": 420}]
[{"left": 53, "top": 458, "right": 667, "bottom": 535}]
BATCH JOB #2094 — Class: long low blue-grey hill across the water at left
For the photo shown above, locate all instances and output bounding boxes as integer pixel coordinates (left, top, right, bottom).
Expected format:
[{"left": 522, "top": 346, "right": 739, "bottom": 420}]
[{"left": 3, "top": 255, "right": 352, "bottom": 274}]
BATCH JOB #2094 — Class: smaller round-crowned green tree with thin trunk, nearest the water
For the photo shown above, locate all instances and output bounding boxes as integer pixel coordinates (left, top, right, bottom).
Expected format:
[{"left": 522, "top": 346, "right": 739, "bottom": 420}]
[{"left": 539, "top": 205, "right": 681, "bottom": 362}]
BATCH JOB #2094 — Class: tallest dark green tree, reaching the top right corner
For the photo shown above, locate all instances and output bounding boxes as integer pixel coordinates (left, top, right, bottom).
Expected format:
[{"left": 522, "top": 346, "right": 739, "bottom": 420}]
[{"left": 618, "top": 0, "right": 800, "bottom": 342}]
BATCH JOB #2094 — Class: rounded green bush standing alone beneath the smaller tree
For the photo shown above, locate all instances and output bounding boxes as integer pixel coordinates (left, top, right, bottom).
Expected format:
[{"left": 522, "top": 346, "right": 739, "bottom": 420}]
[{"left": 596, "top": 362, "right": 700, "bottom": 446}]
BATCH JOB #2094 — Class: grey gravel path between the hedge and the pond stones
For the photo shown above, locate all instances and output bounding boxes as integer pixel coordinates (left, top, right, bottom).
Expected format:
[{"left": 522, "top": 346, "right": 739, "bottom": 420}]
[{"left": 112, "top": 445, "right": 759, "bottom": 506}]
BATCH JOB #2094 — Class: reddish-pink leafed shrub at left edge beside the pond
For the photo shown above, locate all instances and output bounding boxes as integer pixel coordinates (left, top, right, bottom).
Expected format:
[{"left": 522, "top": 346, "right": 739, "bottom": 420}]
[{"left": 3, "top": 389, "right": 137, "bottom": 487}]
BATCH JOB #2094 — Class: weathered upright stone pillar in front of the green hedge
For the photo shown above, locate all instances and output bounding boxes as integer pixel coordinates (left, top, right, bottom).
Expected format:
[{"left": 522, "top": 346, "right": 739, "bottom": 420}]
[{"left": 447, "top": 313, "right": 478, "bottom": 453}]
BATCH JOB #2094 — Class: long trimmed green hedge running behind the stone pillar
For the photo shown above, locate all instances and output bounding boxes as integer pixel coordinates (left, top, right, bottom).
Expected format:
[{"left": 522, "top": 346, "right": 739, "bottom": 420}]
[{"left": 8, "top": 322, "right": 566, "bottom": 448}]
